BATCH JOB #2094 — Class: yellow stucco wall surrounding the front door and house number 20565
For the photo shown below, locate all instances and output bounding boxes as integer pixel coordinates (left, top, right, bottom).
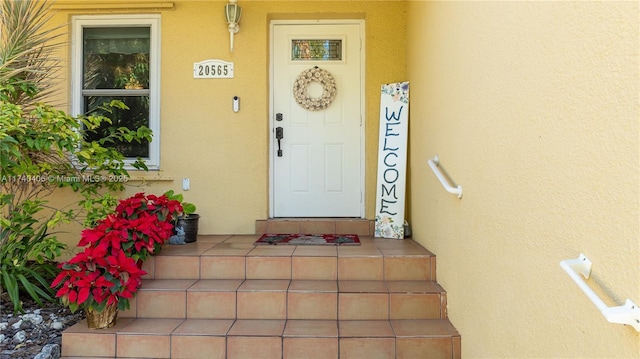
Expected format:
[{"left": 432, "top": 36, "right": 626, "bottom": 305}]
[{"left": 48, "top": 0, "right": 406, "bottom": 242}]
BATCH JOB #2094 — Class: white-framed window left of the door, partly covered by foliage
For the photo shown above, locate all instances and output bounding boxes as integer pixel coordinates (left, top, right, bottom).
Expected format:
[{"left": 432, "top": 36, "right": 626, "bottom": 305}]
[{"left": 72, "top": 15, "right": 160, "bottom": 169}]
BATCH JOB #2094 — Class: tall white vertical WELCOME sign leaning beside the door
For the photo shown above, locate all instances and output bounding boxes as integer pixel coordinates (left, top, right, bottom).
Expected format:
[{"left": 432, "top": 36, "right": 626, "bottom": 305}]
[{"left": 375, "top": 82, "right": 409, "bottom": 239}]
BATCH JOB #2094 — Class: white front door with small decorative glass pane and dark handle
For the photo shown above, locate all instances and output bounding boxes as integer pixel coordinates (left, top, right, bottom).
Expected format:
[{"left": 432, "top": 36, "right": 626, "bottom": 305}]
[{"left": 270, "top": 22, "right": 364, "bottom": 217}]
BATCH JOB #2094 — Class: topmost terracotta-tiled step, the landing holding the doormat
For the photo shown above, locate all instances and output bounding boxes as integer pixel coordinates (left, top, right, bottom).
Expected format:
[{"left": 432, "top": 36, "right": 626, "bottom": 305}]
[{"left": 143, "top": 235, "right": 436, "bottom": 281}]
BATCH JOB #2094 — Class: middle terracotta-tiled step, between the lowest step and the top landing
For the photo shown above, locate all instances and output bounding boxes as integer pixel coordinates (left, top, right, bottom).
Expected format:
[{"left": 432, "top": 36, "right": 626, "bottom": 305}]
[{"left": 120, "top": 279, "right": 447, "bottom": 320}]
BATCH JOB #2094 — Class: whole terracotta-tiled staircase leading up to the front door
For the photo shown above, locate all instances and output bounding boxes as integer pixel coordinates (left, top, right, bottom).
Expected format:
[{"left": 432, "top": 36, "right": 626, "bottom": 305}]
[{"left": 62, "top": 233, "right": 460, "bottom": 359}]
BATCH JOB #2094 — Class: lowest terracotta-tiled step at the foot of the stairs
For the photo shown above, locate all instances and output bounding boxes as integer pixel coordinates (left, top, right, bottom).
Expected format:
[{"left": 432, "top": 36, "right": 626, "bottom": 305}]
[{"left": 62, "top": 319, "right": 461, "bottom": 359}]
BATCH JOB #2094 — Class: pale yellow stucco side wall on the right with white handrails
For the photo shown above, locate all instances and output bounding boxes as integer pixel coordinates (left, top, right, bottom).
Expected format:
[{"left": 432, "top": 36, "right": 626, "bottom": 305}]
[{"left": 407, "top": 1, "right": 640, "bottom": 358}]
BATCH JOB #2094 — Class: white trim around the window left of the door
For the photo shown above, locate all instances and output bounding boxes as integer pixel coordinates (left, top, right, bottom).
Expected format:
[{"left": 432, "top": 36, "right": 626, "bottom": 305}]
[{"left": 71, "top": 15, "right": 160, "bottom": 170}]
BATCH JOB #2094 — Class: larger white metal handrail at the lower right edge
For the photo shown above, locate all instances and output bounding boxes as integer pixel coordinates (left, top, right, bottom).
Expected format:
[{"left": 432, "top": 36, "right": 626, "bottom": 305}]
[{"left": 560, "top": 253, "right": 640, "bottom": 332}]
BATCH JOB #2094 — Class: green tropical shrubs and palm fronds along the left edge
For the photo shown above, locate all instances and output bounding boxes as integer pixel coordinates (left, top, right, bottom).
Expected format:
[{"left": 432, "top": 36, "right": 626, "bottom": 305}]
[{"left": 0, "top": 0, "right": 151, "bottom": 312}]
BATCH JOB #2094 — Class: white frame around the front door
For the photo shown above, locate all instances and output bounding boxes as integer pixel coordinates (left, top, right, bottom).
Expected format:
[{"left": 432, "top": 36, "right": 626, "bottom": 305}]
[{"left": 268, "top": 19, "right": 366, "bottom": 218}]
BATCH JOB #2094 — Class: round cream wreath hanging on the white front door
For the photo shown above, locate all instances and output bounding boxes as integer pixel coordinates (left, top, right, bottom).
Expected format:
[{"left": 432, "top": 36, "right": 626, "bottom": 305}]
[{"left": 293, "top": 66, "right": 337, "bottom": 111}]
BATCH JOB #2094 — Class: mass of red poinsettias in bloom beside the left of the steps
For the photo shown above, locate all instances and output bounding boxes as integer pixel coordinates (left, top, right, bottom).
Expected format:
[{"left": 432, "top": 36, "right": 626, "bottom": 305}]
[{"left": 51, "top": 191, "right": 183, "bottom": 312}]
